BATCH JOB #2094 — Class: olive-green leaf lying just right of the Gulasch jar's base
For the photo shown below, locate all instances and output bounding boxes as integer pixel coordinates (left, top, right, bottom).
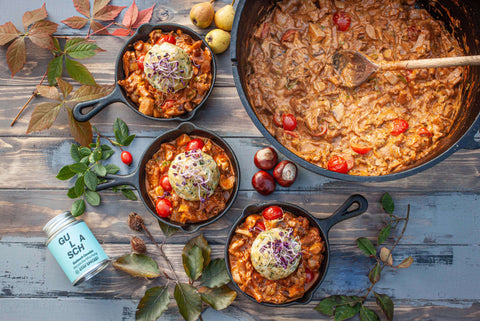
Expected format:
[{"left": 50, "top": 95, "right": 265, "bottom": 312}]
[{"left": 113, "top": 253, "right": 160, "bottom": 278}]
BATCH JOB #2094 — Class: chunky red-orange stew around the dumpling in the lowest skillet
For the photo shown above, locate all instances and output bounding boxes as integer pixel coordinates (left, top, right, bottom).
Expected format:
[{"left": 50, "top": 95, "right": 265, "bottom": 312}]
[{"left": 228, "top": 212, "right": 325, "bottom": 304}]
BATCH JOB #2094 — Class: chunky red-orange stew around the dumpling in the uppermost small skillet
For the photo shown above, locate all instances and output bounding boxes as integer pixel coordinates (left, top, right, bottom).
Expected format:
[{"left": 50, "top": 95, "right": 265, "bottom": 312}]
[{"left": 118, "top": 29, "right": 213, "bottom": 118}]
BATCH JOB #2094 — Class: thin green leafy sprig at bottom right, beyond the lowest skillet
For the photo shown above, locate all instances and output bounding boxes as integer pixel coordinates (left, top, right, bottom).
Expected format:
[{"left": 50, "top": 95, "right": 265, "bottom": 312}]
[{"left": 315, "top": 193, "right": 413, "bottom": 321}]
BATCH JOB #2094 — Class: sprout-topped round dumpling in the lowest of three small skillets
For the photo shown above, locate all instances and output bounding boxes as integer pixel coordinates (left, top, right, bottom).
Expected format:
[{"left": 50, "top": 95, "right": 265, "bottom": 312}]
[{"left": 250, "top": 228, "right": 302, "bottom": 280}]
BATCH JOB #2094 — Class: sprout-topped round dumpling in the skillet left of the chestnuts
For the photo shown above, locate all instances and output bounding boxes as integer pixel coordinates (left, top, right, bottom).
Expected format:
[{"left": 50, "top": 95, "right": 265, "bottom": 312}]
[{"left": 168, "top": 149, "right": 220, "bottom": 201}]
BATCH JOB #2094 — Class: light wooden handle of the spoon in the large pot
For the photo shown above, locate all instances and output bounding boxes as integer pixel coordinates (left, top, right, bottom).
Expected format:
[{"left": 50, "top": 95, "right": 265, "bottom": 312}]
[{"left": 380, "top": 55, "right": 480, "bottom": 70}]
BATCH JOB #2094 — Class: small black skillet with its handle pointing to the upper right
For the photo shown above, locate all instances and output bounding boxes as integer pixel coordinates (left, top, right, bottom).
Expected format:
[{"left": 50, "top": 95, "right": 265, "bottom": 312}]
[{"left": 225, "top": 194, "right": 368, "bottom": 307}]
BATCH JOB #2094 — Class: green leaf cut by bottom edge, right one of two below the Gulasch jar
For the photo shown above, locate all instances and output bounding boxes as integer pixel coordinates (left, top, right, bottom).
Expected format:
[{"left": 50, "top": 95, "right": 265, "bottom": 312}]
[{"left": 173, "top": 283, "right": 202, "bottom": 321}]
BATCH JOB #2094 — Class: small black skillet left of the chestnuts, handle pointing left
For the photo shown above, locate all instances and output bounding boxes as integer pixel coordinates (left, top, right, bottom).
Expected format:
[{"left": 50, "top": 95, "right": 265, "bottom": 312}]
[{"left": 97, "top": 122, "right": 240, "bottom": 233}]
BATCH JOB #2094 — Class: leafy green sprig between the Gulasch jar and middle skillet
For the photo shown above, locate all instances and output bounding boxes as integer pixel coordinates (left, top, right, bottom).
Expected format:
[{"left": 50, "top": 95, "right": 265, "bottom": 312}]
[{"left": 56, "top": 118, "right": 137, "bottom": 216}]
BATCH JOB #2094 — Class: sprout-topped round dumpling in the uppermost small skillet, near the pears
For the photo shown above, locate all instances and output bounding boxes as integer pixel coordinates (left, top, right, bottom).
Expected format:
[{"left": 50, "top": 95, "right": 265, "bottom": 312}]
[{"left": 143, "top": 42, "right": 193, "bottom": 93}]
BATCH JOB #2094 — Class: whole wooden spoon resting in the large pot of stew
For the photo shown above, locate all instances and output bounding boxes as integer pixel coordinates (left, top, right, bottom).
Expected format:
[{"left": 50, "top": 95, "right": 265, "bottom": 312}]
[{"left": 333, "top": 50, "right": 480, "bottom": 88}]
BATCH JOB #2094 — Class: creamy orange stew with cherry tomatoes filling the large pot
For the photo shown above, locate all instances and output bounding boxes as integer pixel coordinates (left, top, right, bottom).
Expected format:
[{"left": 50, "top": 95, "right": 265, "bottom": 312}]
[{"left": 246, "top": 0, "right": 465, "bottom": 176}]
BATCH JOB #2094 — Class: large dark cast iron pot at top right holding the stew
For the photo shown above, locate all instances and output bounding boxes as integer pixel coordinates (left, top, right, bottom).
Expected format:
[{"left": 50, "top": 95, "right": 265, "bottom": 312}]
[{"left": 231, "top": 0, "right": 480, "bottom": 182}]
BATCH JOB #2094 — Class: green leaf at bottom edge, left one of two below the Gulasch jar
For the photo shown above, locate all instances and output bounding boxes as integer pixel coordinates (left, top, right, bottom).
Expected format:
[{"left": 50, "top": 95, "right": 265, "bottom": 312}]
[{"left": 135, "top": 286, "right": 170, "bottom": 321}]
